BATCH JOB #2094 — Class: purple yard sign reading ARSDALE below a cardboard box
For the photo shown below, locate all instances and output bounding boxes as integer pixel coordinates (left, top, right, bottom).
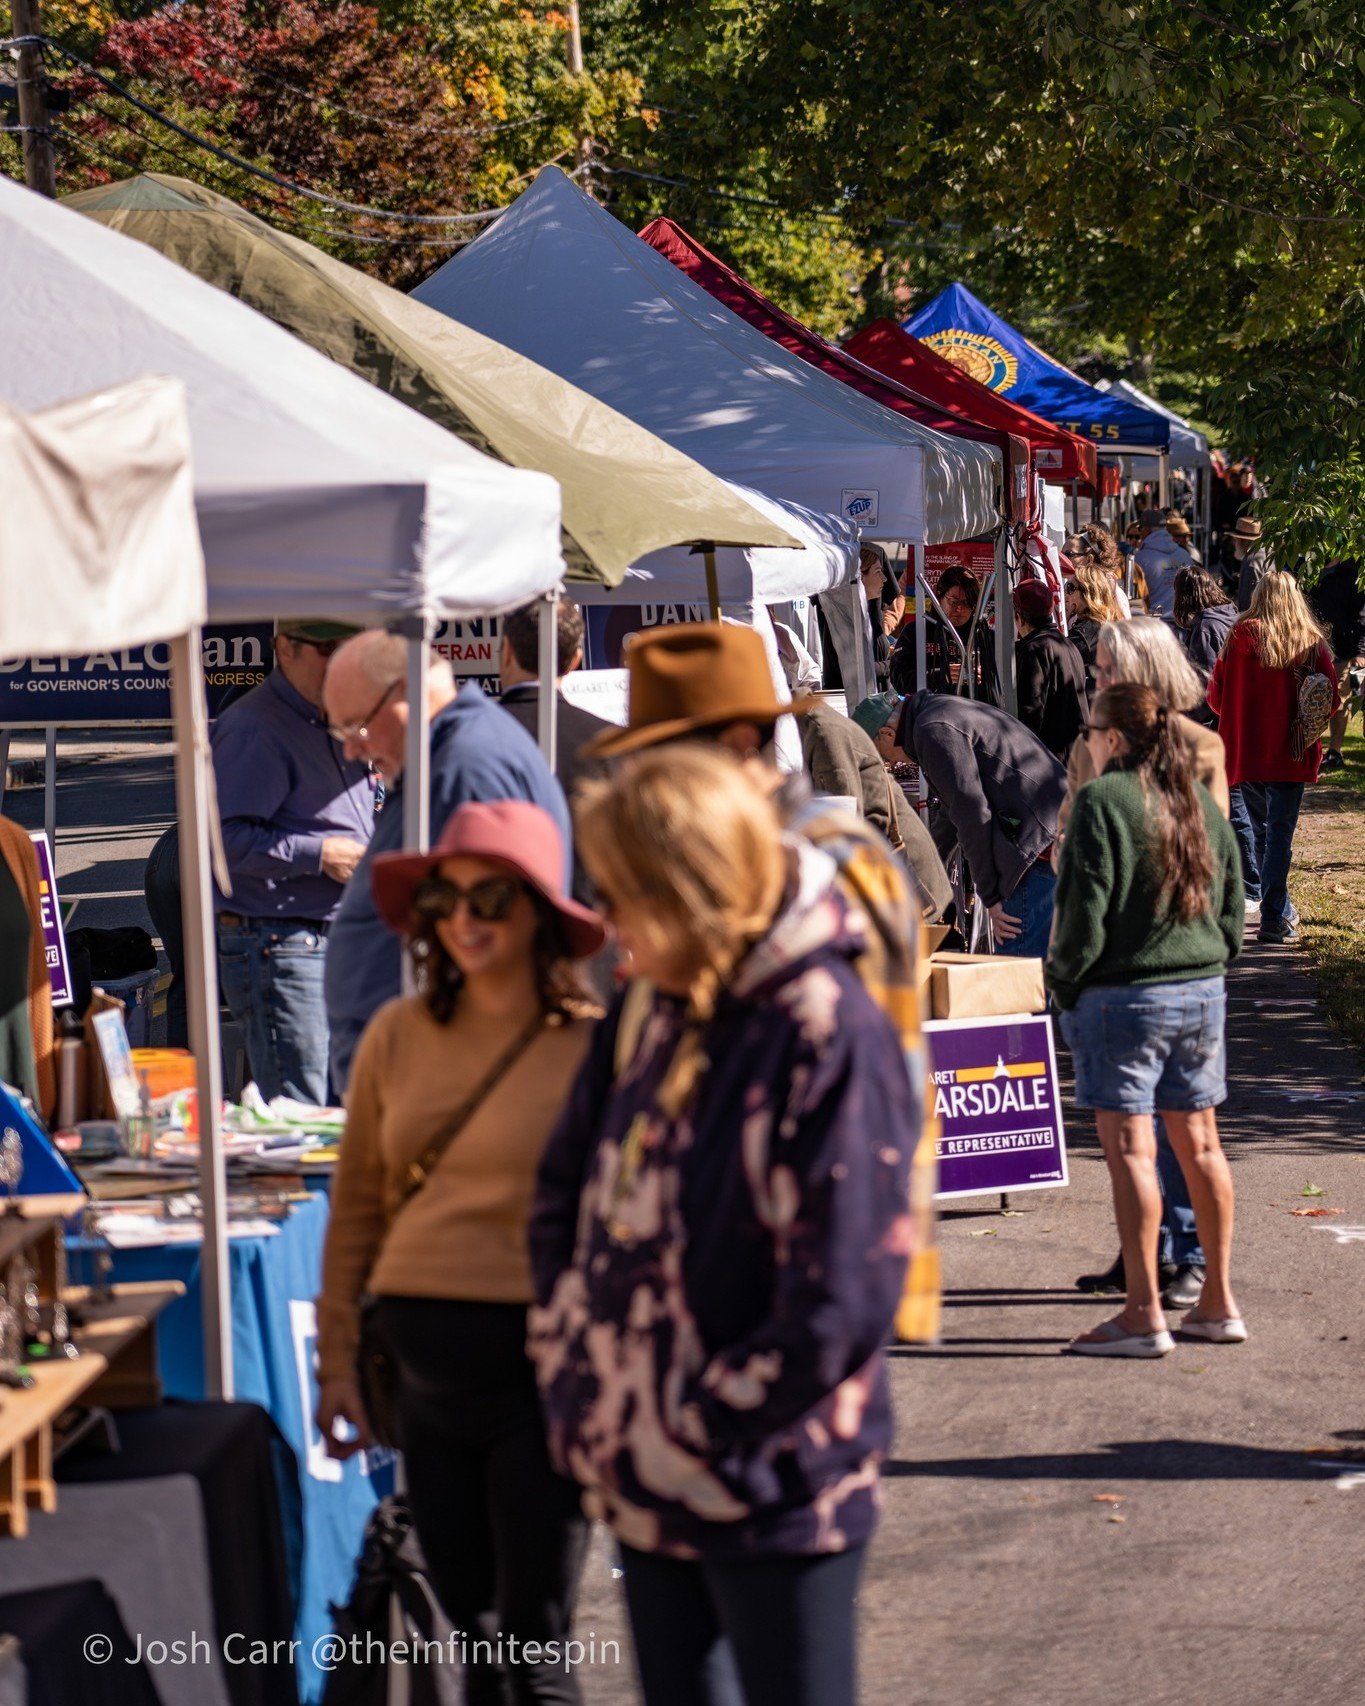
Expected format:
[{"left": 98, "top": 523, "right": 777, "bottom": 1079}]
[{"left": 925, "top": 1015, "right": 1066, "bottom": 1201}]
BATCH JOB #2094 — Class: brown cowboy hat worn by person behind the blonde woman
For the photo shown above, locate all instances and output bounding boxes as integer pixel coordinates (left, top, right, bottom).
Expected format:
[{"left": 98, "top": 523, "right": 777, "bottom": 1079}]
[{"left": 584, "top": 623, "right": 816, "bottom": 757}]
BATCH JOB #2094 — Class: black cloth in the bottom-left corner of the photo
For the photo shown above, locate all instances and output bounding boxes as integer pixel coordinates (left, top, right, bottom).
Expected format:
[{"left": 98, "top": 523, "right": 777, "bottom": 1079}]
[{"left": 0, "top": 1576, "right": 159, "bottom": 1706}]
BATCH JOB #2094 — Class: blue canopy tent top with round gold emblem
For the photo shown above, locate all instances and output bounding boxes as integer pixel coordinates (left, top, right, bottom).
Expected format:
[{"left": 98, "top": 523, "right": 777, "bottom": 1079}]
[{"left": 904, "top": 285, "right": 1170, "bottom": 450}]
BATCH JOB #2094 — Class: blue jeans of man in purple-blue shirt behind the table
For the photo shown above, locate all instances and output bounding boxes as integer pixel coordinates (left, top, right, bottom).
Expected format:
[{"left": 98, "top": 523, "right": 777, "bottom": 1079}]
[{"left": 218, "top": 918, "right": 328, "bottom": 1105}]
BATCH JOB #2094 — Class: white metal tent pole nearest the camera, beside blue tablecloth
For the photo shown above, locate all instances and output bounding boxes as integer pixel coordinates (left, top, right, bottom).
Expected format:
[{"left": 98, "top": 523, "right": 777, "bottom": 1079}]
[{"left": 171, "top": 628, "right": 234, "bottom": 1399}]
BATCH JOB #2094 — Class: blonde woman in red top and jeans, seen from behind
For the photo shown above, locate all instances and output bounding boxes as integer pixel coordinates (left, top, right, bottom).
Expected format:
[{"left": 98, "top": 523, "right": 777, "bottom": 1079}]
[{"left": 1208, "top": 570, "right": 1341, "bottom": 942}]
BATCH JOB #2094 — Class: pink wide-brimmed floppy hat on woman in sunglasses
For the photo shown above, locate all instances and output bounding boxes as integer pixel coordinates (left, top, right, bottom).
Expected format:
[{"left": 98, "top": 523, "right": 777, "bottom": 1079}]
[{"left": 370, "top": 800, "right": 607, "bottom": 959}]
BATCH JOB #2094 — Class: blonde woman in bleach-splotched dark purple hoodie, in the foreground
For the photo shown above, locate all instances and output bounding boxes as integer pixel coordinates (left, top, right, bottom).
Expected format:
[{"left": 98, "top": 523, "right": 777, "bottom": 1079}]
[{"left": 531, "top": 744, "right": 921, "bottom": 1706}]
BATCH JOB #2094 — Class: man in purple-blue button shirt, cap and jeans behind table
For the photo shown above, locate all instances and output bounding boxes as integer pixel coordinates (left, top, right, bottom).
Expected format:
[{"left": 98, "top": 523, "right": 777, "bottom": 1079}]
[{"left": 212, "top": 619, "right": 374, "bottom": 1104}]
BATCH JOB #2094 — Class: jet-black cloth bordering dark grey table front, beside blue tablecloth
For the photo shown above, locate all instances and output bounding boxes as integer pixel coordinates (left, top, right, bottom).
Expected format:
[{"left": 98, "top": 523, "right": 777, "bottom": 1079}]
[{"left": 56, "top": 1402, "right": 302, "bottom": 1706}]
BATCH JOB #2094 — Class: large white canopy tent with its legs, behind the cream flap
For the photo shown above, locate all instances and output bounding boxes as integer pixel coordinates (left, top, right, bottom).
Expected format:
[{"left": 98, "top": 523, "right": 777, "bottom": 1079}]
[{"left": 0, "top": 177, "right": 563, "bottom": 1396}]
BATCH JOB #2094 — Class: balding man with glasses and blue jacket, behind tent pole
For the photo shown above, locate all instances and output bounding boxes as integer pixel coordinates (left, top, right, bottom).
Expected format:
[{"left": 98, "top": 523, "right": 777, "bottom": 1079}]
[{"left": 322, "top": 631, "right": 572, "bottom": 1094}]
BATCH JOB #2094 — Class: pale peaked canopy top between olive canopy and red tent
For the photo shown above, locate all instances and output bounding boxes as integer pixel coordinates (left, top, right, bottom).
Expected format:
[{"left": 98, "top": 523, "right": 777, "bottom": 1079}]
[{"left": 413, "top": 167, "right": 1002, "bottom": 544}]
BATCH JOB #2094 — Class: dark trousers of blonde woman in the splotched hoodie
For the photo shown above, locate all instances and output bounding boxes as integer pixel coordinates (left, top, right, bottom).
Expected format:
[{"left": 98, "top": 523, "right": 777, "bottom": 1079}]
[{"left": 621, "top": 1546, "right": 865, "bottom": 1706}]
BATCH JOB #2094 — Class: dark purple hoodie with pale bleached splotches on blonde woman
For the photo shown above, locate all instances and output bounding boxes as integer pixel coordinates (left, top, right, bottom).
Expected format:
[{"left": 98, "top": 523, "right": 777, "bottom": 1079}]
[{"left": 531, "top": 846, "right": 921, "bottom": 1558}]
